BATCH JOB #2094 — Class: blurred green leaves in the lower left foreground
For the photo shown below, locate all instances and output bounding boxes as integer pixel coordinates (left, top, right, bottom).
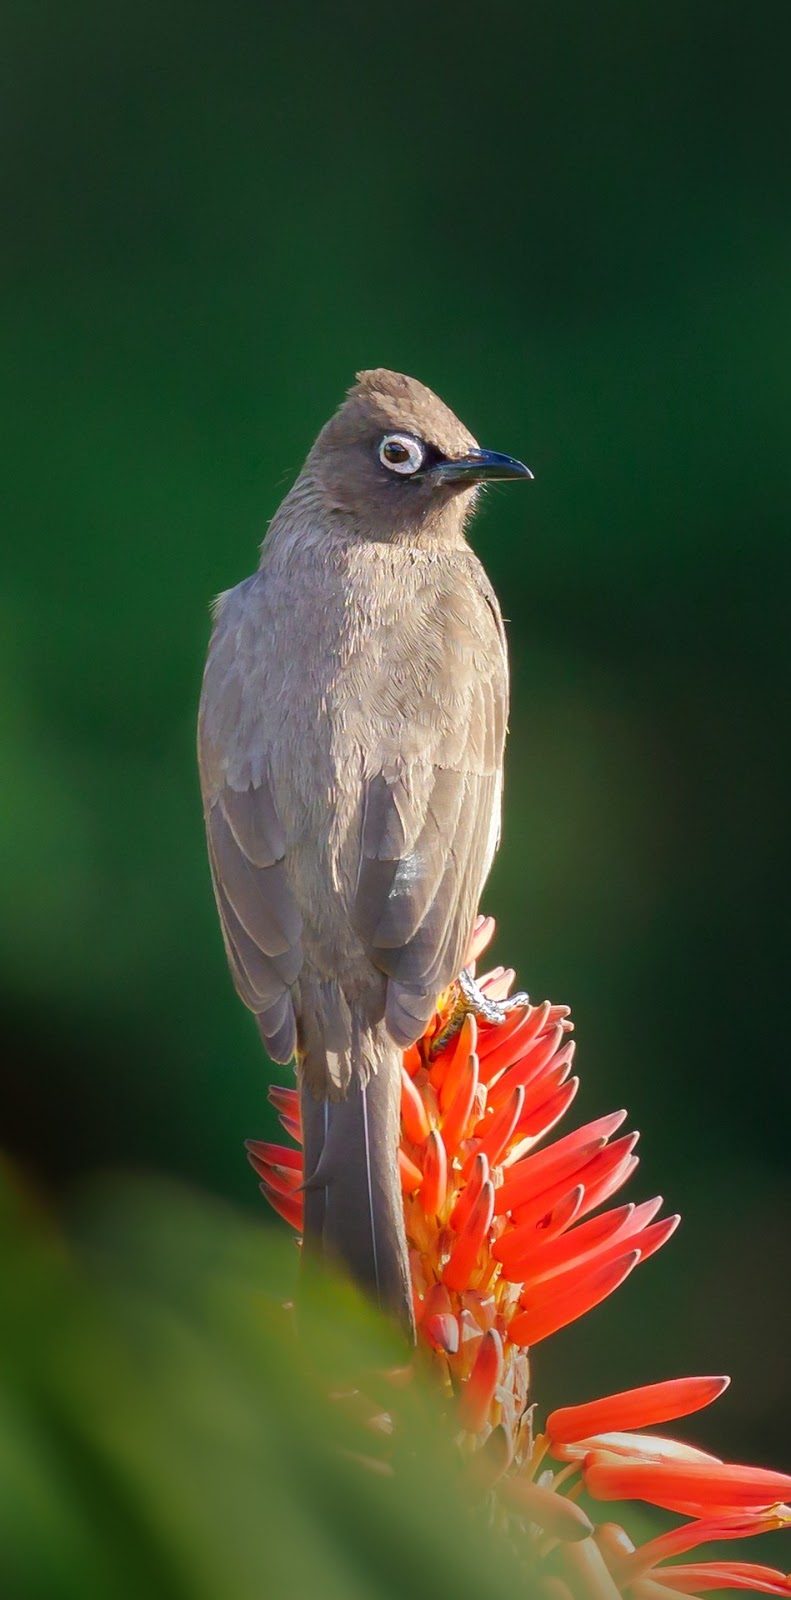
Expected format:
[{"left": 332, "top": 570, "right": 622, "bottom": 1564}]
[{"left": 0, "top": 1186, "right": 541, "bottom": 1600}]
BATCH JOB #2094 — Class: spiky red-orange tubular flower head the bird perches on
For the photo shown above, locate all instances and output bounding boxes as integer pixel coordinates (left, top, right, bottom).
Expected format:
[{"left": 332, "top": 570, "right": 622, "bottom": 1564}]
[{"left": 248, "top": 918, "right": 791, "bottom": 1600}]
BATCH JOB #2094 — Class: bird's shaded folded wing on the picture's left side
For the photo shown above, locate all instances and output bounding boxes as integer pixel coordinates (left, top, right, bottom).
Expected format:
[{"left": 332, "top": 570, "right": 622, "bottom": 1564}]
[{"left": 199, "top": 584, "right": 303, "bottom": 1061}]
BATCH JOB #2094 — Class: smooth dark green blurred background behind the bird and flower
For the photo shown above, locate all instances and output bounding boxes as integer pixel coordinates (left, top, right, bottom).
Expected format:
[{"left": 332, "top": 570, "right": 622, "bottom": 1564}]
[{"left": 0, "top": 0, "right": 791, "bottom": 1497}]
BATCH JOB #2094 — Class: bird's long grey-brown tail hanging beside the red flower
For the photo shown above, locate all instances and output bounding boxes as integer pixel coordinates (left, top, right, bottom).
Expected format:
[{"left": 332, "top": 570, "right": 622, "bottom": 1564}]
[{"left": 299, "top": 1014, "right": 413, "bottom": 1333}]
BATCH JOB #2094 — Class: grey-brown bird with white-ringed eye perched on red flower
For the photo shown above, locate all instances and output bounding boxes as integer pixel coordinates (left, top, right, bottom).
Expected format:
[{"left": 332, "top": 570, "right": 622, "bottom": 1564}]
[{"left": 199, "top": 368, "right": 532, "bottom": 1334}]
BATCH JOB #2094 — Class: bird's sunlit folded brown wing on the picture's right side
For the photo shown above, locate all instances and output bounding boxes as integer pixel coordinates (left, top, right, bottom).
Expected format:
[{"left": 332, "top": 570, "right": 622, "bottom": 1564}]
[{"left": 354, "top": 574, "right": 508, "bottom": 1045}]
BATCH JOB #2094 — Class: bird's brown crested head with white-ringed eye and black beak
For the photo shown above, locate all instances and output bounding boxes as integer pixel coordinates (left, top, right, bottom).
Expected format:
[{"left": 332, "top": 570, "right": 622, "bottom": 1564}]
[{"left": 306, "top": 366, "right": 533, "bottom": 542}]
